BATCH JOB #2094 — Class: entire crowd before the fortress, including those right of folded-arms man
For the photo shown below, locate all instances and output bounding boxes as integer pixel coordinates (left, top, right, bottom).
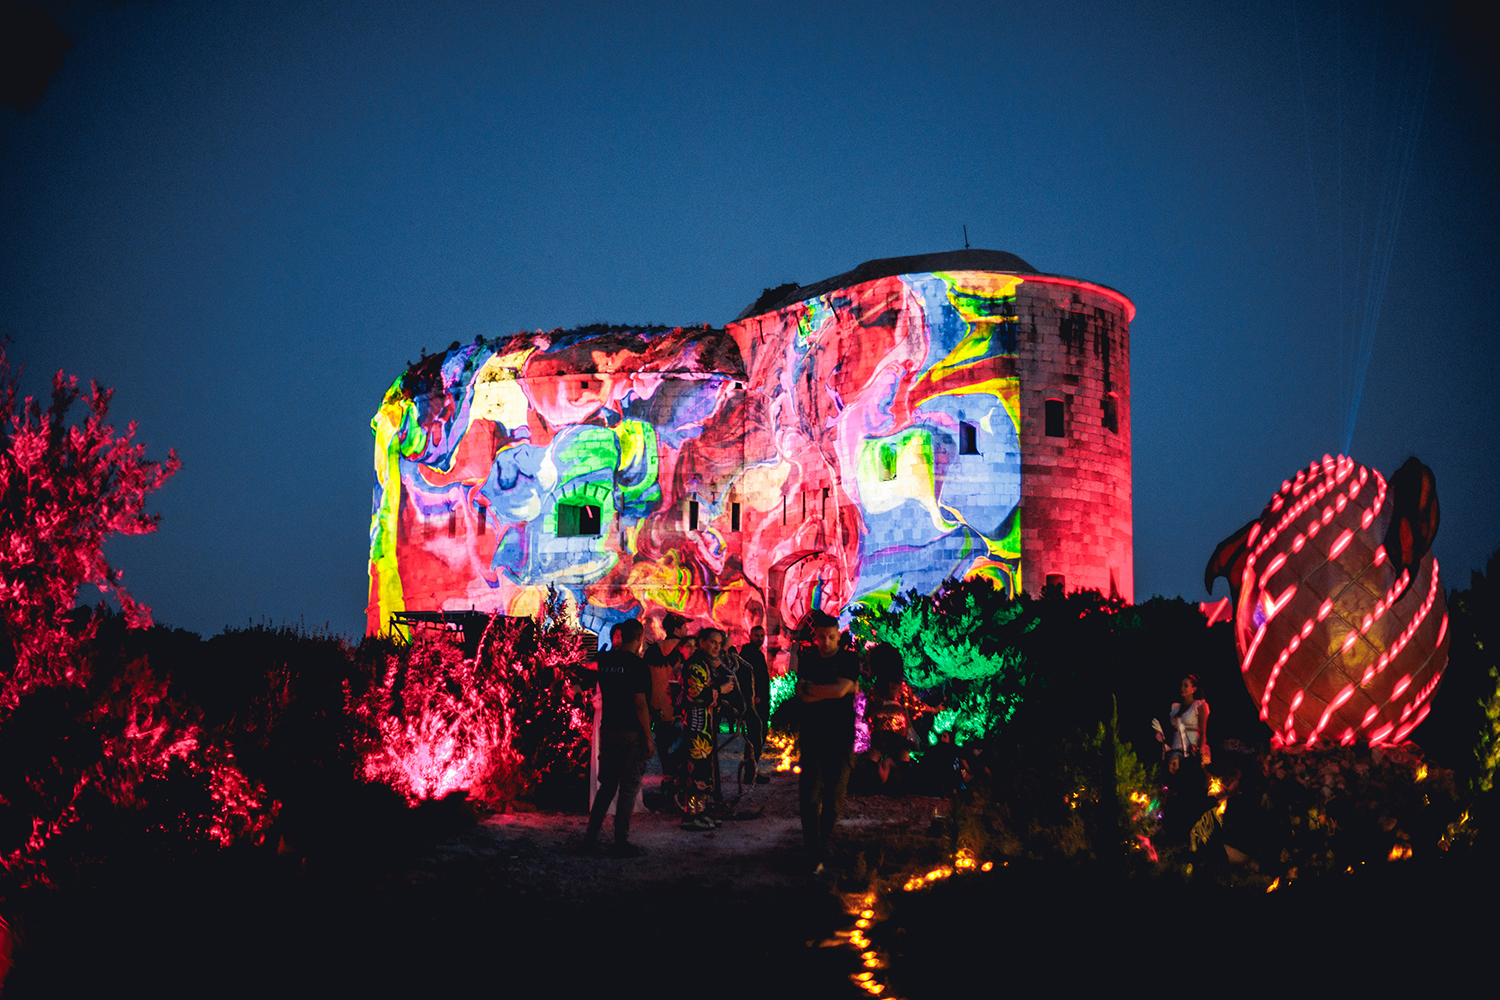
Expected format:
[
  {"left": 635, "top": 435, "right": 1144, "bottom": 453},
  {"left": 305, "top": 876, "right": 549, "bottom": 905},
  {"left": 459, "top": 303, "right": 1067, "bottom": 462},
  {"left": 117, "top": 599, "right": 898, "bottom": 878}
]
[{"left": 585, "top": 612, "right": 996, "bottom": 873}]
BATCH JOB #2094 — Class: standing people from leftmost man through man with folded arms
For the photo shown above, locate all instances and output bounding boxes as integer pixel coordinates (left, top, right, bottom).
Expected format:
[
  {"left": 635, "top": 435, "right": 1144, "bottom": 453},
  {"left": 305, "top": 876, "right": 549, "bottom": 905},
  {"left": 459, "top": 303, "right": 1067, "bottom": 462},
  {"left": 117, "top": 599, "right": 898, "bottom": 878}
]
[{"left": 584, "top": 612, "right": 860, "bottom": 871}]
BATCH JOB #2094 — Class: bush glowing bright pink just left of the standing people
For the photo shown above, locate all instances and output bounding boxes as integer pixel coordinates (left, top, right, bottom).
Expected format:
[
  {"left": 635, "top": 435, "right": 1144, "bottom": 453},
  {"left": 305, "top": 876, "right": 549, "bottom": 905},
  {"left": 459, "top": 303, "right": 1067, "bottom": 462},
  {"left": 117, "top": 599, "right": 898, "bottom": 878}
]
[{"left": 347, "top": 592, "right": 591, "bottom": 805}]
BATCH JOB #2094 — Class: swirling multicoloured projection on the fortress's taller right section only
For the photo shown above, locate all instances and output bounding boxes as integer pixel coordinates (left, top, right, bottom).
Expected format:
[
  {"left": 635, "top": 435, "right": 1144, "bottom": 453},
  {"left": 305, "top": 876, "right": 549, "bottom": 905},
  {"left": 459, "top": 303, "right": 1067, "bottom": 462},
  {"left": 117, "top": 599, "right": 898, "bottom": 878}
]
[{"left": 731, "top": 271, "right": 1022, "bottom": 624}]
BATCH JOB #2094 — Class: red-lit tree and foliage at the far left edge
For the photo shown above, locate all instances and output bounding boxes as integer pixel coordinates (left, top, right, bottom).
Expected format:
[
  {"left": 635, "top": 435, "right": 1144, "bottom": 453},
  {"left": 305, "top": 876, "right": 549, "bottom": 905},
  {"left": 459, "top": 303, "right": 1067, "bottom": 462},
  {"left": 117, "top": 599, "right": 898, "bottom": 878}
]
[{"left": 0, "top": 351, "right": 275, "bottom": 880}]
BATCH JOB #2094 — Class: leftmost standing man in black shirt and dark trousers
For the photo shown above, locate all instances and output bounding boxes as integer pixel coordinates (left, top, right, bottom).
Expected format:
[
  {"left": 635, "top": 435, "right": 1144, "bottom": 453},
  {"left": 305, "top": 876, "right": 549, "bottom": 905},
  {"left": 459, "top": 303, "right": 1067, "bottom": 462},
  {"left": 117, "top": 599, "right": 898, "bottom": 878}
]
[{"left": 584, "top": 619, "right": 653, "bottom": 858}]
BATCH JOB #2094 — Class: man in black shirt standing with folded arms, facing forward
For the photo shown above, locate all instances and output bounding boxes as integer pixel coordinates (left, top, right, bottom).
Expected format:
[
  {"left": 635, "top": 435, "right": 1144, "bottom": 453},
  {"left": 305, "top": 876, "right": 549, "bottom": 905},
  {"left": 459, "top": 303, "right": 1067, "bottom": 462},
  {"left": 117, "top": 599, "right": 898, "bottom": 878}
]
[{"left": 792, "top": 612, "right": 860, "bottom": 873}]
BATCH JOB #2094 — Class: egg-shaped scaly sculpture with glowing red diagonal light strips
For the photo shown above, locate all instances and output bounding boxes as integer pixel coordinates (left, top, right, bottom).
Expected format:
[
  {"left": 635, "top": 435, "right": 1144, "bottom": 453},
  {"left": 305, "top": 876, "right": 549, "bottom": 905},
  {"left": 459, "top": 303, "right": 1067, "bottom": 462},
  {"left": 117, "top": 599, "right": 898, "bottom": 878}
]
[{"left": 1202, "top": 456, "right": 1448, "bottom": 747}]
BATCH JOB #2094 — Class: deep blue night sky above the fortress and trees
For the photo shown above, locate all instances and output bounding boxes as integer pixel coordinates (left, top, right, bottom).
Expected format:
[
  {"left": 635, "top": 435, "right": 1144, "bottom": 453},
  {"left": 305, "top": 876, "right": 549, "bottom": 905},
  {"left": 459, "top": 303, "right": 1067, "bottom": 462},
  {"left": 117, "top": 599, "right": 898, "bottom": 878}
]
[{"left": 0, "top": 0, "right": 1500, "bottom": 634}]
